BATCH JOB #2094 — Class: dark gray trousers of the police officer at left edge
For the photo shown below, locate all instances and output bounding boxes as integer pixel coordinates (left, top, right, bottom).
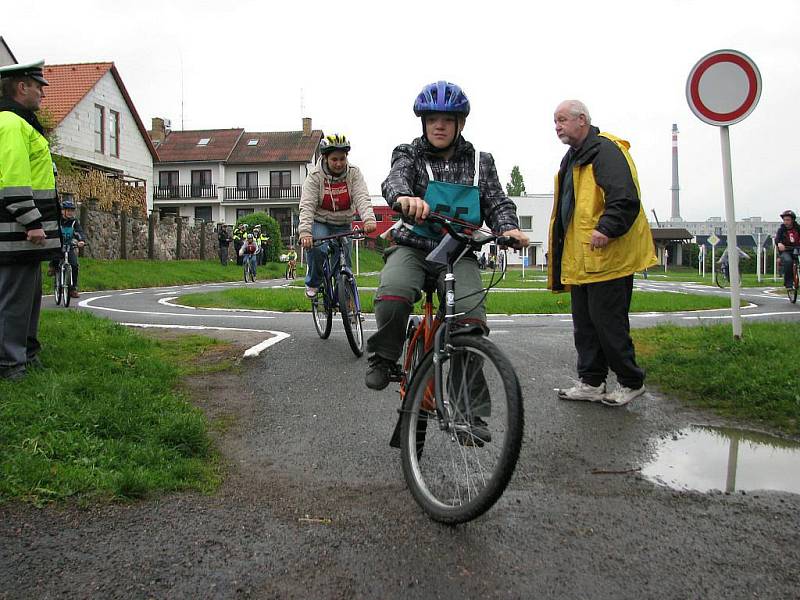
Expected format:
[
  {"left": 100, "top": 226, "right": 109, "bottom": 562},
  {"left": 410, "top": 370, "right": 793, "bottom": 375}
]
[{"left": 0, "top": 262, "right": 42, "bottom": 369}]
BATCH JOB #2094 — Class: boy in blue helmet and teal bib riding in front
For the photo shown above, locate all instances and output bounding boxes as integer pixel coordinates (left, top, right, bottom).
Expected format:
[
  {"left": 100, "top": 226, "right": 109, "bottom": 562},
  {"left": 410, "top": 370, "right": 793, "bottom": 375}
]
[{"left": 365, "top": 81, "right": 528, "bottom": 390}]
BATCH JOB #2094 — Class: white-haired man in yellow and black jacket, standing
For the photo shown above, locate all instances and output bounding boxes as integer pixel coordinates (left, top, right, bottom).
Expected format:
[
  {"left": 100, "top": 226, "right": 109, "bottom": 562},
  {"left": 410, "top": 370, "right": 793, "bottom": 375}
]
[{"left": 548, "top": 100, "right": 657, "bottom": 406}]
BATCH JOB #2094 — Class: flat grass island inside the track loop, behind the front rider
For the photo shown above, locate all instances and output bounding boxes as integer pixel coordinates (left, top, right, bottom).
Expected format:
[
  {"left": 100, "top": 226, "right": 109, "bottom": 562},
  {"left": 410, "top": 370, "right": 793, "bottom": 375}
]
[{"left": 178, "top": 288, "right": 730, "bottom": 314}]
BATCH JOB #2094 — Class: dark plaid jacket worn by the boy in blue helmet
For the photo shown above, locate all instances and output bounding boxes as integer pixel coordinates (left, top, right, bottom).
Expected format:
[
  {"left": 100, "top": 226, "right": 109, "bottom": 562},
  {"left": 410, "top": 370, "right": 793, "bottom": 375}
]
[{"left": 381, "top": 135, "right": 519, "bottom": 250}]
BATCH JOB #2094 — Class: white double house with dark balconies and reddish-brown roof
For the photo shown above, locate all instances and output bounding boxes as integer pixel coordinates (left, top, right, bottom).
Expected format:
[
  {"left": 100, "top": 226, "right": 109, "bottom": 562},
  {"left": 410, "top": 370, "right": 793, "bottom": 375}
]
[{"left": 150, "top": 118, "right": 322, "bottom": 237}]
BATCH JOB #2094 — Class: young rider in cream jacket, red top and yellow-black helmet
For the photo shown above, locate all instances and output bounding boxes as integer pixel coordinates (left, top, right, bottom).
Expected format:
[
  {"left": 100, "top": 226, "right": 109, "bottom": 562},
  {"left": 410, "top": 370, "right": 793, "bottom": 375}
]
[{"left": 297, "top": 133, "right": 377, "bottom": 298}]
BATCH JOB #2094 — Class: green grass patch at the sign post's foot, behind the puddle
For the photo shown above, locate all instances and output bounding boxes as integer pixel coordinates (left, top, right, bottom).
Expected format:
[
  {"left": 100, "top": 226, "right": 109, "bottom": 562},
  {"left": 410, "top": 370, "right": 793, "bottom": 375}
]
[{"left": 632, "top": 323, "right": 800, "bottom": 435}]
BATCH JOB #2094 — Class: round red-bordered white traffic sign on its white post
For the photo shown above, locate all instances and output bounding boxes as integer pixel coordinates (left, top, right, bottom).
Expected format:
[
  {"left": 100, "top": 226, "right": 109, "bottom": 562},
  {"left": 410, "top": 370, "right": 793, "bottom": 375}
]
[{"left": 686, "top": 50, "right": 761, "bottom": 339}]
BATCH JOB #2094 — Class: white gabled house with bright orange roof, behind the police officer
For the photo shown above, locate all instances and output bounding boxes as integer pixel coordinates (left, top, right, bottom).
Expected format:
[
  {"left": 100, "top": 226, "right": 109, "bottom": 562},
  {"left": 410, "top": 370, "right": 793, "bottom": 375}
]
[{"left": 42, "top": 62, "right": 157, "bottom": 209}]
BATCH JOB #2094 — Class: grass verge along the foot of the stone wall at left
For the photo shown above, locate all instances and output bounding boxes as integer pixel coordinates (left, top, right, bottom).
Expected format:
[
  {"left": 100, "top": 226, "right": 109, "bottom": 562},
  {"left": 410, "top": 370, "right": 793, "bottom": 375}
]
[{"left": 42, "top": 258, "right": 305, "bottom": 294}]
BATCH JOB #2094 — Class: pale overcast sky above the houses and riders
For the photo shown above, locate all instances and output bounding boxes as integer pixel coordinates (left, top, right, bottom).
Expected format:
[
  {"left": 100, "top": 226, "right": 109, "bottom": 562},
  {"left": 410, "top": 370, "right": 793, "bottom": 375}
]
[{"left": 6, "top": 0, "right": 800, "bottom": 221}]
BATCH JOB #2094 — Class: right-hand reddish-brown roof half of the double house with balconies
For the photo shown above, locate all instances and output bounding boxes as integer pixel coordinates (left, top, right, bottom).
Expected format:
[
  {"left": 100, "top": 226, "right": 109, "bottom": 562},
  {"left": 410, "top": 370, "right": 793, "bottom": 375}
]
[{"left": 228, "top": 129, "right": 322, "bottom": 163}]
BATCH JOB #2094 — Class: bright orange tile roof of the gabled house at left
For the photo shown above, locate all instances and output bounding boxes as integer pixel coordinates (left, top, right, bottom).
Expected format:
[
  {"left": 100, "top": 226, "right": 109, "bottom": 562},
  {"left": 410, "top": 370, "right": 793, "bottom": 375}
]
[{"left": 42, "top": 62, "right": 158, "bottom": 160}]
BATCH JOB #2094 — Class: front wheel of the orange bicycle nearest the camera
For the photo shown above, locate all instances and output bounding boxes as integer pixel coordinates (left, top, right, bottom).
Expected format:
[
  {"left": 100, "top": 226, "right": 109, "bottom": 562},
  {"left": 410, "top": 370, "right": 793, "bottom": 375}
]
[{"left": 400, "top": 335, "right": 524, "bottom": 524}]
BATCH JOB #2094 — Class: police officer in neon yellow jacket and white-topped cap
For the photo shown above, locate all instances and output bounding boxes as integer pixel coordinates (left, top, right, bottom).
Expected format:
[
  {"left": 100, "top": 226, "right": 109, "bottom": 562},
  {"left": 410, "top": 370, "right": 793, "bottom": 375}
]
[{"left": 0, "top": 61, "right": 61, "bottom": 380}]
